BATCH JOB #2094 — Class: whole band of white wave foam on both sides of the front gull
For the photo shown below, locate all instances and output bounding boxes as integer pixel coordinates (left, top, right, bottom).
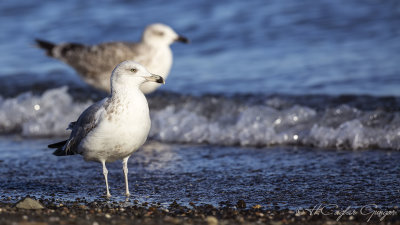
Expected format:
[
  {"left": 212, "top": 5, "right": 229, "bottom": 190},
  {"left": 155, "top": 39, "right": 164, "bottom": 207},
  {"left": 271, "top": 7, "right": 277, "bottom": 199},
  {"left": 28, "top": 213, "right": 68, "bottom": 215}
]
[{"left": 0, "top": 87, "right": 400, "bottom": 150}]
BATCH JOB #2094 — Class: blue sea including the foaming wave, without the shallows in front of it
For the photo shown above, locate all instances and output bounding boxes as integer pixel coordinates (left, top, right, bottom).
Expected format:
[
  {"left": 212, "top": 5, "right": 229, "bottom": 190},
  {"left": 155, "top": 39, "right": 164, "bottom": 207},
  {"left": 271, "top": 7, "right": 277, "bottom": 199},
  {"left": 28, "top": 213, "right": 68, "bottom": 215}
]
[{"left": 0, "top": 0, "right": 400, "bottom": 150}]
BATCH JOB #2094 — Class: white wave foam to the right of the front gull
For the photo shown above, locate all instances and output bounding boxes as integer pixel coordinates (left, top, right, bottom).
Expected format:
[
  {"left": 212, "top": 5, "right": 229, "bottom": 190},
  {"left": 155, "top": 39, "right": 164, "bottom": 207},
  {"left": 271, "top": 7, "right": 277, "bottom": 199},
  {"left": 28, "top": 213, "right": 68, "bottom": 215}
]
[{"left": 151, "top": 98, "right": 400, "bottom": 149}]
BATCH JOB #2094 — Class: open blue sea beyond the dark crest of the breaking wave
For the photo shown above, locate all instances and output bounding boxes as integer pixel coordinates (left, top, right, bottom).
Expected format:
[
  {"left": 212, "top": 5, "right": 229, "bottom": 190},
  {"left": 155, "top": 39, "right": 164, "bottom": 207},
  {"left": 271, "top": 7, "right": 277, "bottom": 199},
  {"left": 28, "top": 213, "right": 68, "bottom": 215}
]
[{"left": 0, "top": 0, "right": 400, "bottom": 96}]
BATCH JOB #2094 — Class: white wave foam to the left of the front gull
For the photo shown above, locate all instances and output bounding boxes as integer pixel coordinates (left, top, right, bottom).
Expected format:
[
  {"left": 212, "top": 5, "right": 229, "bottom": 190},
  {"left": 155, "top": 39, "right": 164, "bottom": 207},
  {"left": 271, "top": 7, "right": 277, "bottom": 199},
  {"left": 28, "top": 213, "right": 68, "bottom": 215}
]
[{"left": 0, "top": 87, "right": 91, "bottom": 137}]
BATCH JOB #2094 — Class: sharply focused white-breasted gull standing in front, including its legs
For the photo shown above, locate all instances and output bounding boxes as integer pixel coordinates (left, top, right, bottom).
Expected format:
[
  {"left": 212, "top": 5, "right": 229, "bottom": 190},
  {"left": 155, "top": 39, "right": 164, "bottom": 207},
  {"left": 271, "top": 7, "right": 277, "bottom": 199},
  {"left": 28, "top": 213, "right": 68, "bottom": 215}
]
[{"left": 49, "top": 61, "right": 164, "bottom": 197}]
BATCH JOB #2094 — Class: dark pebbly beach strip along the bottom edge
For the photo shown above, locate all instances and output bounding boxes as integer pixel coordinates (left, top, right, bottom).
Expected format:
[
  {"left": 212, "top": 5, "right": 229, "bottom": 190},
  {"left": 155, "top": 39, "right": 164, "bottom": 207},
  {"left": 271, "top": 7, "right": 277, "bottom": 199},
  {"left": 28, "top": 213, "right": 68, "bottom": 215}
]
[{"left": 0, "top": 199, "right": 400, "bottom": 225}]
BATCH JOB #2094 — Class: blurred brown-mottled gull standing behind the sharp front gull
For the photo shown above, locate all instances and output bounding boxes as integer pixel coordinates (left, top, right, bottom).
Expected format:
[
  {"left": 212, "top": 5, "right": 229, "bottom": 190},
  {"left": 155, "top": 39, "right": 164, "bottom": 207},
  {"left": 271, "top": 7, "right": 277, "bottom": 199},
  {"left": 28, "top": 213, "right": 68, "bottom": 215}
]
[{"left": 36, "top": 23, "right": 189, "bottom": 94}]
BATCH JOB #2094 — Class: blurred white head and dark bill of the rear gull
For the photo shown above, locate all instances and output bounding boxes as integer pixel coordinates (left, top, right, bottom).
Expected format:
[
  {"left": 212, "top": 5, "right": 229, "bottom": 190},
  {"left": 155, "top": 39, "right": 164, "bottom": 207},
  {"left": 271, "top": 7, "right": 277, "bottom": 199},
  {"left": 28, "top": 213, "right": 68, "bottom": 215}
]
[{"left": 142, "top": 23, "right": 189, "bottom": 46}]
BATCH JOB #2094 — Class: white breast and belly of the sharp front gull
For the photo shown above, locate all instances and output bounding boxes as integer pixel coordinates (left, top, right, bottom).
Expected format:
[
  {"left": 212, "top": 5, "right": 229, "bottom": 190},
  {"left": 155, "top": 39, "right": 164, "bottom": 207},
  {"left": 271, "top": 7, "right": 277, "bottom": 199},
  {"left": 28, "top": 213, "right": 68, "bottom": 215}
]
[{"left": 81, "top": 96, "right": 151, "bottom": 162}]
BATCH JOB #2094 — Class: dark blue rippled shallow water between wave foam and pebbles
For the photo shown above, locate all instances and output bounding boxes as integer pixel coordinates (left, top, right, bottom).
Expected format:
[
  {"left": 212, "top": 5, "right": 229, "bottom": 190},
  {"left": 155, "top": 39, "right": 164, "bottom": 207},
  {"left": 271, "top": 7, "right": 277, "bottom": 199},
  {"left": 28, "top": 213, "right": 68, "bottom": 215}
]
[{"left": 0, "top": 140, "right": 400, "bottom": 210}]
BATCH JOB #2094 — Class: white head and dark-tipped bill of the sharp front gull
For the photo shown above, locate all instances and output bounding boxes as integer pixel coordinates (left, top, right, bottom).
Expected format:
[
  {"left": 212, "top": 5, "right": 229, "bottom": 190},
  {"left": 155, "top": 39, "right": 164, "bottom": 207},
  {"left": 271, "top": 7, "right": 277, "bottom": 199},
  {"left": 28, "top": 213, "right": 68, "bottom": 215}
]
[{"left": 111, "top": 60, "right": 165, "bottom": 91}]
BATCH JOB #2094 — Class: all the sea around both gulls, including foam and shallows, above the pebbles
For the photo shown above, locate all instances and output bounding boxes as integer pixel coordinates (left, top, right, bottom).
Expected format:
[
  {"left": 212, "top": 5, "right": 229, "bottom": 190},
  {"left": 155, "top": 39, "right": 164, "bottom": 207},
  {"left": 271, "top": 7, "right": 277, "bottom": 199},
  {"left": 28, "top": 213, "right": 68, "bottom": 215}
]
[{"left": 0, "top": 0, "right": 400, "bottom": 207}]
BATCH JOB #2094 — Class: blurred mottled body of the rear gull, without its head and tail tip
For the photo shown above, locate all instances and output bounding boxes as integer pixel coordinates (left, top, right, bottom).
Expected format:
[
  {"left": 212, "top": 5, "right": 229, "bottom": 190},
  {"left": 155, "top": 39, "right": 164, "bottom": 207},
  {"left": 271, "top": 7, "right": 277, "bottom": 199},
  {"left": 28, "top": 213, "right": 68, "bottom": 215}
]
[{"left": 53, "top": 42, "right": 168, "bottom": 93}]
